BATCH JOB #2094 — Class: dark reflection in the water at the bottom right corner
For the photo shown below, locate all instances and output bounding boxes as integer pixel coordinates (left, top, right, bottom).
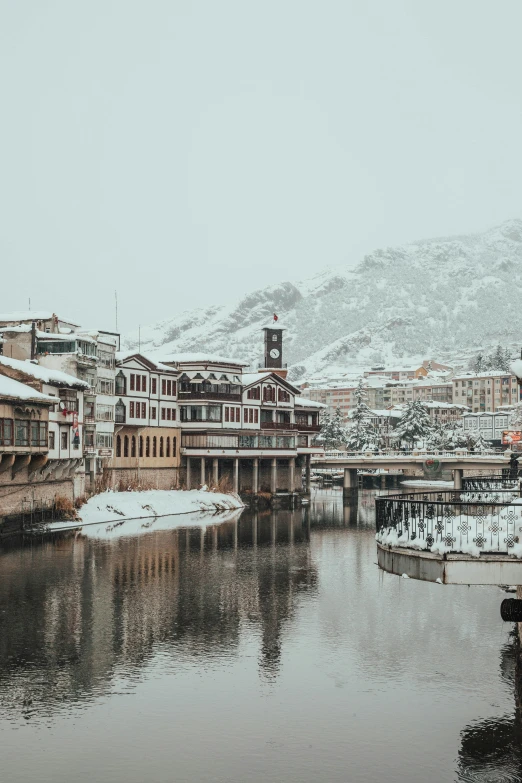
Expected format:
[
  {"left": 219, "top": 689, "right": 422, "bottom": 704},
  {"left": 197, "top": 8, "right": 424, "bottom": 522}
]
[{"left": 458, "top": 636, "right": 522, "bottom": 781}]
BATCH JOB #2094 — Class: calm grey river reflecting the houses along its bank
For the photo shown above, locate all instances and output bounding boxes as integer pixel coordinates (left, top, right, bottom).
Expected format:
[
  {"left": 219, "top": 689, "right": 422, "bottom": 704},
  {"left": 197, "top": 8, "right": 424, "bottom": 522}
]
[{"left": 0, "top": 489, "right": 522, "bottom": 783}]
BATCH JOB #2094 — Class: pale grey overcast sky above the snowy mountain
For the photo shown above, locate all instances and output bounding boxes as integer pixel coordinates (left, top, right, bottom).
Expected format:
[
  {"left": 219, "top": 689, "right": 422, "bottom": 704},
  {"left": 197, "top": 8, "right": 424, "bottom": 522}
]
[{"left": 0, "top": 0, "right": 522, "bottom": 332}]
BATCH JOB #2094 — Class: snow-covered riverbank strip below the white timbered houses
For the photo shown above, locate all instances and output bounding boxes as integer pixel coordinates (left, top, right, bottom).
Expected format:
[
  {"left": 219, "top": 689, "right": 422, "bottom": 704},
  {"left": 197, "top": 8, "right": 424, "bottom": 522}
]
[{"left": 42, "top": 487, "right": 244, "bottom": 537}]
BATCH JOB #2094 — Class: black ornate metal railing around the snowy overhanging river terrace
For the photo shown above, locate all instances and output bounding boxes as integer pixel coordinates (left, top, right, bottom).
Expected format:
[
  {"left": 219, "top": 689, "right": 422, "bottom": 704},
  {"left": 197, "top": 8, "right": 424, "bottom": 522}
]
[{"left": 375, "top": 486, "right": 522, "bottom": 556}]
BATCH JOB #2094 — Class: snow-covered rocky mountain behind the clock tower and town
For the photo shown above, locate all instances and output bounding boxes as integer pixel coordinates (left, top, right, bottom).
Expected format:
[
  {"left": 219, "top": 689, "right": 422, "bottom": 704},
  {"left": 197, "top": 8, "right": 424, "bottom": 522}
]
[{"left": 126, "top": 220, "right": 522, "bottom": 380}]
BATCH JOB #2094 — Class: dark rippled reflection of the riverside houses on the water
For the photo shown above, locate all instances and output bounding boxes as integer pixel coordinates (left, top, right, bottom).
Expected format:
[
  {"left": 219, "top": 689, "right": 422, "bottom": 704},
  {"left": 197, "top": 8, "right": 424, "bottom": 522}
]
[{"left": 0, "top": 509, "right": 317, "bottom": 714}]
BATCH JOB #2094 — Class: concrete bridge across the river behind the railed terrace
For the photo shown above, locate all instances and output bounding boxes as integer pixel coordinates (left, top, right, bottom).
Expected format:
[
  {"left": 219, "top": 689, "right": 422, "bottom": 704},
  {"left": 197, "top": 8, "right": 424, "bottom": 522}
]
[{"left": 311, "top": 449, "right": 511, "bottom": 495}]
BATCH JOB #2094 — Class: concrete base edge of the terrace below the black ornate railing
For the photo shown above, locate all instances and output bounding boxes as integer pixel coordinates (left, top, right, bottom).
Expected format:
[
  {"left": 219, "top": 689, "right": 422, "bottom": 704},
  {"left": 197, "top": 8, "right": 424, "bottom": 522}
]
[{"left": 377, "top": 543, "right": 522, "bottom": 585}]
